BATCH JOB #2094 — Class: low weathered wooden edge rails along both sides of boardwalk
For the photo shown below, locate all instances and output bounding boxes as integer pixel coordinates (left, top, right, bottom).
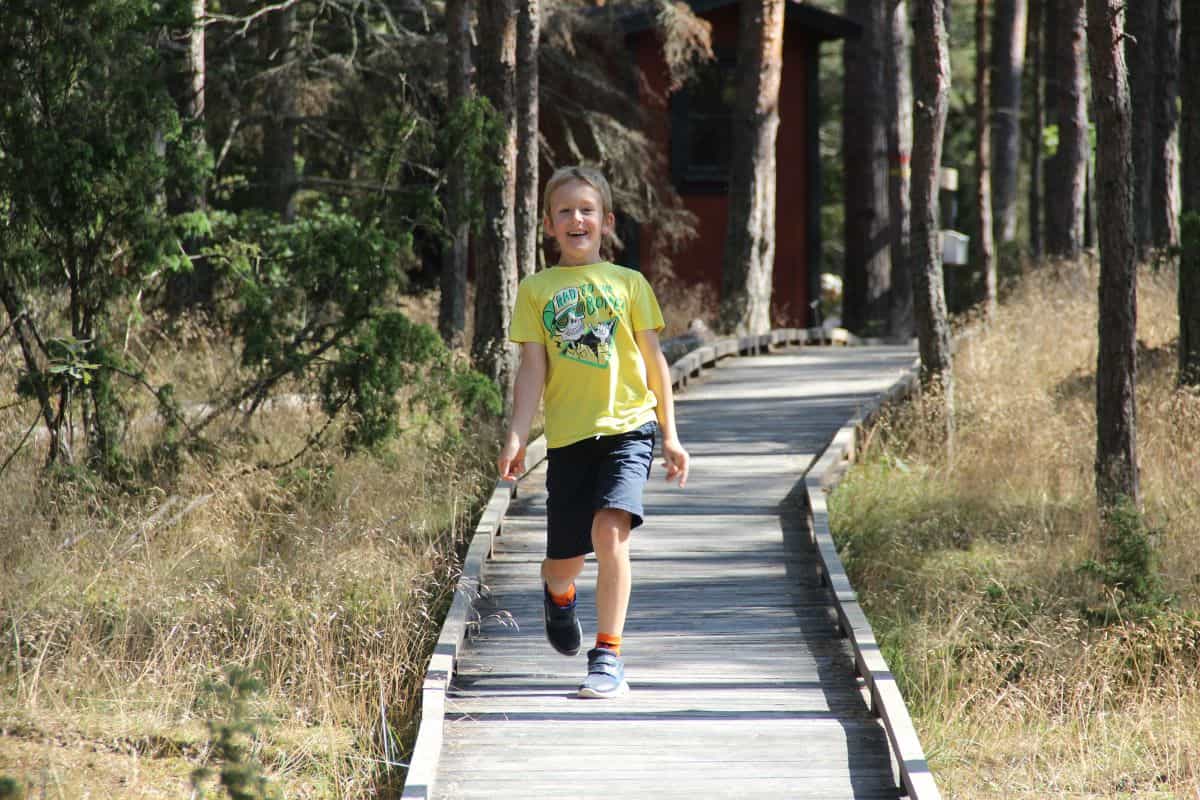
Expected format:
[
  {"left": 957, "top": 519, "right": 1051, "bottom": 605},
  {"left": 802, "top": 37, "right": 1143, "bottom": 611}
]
[{"left": 402, "top": 327, "right": 941, "bottom": 800}]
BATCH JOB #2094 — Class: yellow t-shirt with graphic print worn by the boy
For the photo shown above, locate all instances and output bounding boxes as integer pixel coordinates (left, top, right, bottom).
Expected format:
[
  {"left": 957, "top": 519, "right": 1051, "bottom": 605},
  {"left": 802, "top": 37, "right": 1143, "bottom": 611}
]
[{"left": 509, "top": 261, "right": 662, "bottom": 447}]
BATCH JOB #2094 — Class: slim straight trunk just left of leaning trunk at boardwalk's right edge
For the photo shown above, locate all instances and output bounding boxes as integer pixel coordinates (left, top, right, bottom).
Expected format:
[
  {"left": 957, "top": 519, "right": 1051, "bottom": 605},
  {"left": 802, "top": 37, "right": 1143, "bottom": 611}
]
[{"left": 883, "top": 0, "right": 916, "bottom": 339}]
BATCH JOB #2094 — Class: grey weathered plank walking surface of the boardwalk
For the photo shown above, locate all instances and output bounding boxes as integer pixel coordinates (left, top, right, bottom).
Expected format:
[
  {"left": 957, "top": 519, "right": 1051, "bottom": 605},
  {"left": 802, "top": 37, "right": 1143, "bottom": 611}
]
[{"left": 433, "top": 347, "right": 914, "bottom": 800}]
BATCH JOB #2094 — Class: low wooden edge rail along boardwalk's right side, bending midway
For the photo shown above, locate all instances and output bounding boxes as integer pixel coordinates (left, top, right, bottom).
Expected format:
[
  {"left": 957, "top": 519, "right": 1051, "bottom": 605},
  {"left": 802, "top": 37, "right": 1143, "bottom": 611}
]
[{"left": 804, "top": 359, "right": 941, "bottom": 800}]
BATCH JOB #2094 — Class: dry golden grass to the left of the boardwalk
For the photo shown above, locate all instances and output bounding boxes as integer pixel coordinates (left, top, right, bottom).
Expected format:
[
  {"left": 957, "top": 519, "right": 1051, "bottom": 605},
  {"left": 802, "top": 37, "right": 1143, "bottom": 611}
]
[{"left": 0, "top": 311, "right": 498, "bottom": 798}]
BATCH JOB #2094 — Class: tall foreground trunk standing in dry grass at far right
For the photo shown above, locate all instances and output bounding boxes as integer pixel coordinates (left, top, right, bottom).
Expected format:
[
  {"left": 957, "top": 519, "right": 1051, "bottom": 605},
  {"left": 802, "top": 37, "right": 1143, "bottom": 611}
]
[{"left": 1087, "top": 0, "right": 1140, "bottom": 509}]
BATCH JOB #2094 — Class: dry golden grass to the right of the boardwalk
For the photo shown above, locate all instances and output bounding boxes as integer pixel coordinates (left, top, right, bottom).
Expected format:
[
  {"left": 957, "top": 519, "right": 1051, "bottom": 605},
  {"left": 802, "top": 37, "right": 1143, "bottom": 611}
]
[{"left": 833, "top": 257, "right": 1200, "bottom": 800}]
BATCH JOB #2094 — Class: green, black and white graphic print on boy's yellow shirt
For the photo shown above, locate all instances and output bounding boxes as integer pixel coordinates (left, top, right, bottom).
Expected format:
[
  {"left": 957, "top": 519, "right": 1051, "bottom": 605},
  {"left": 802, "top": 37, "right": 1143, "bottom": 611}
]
[{"left": 541, "top": 283, "right": 625, "bottom": 368}]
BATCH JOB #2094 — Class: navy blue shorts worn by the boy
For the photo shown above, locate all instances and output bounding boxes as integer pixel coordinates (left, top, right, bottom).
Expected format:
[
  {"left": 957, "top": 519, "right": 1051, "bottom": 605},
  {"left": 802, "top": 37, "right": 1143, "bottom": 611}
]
[{"left": 546, "top": 422, "right": 659, "bottom": 559}]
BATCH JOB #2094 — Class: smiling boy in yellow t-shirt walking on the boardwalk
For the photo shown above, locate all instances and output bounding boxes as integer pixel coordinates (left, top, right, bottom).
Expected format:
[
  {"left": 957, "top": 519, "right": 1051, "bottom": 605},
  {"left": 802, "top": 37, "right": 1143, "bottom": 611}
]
[{"left": 497, "top": 167, "right": 688, "bottom": 697}]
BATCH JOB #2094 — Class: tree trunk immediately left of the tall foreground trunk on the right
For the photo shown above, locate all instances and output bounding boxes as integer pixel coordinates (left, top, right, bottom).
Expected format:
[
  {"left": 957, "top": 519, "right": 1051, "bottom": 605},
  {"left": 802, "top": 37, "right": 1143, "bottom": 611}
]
[{"left": 1045, "top": 0, "right": 1088, "bottom": 258}]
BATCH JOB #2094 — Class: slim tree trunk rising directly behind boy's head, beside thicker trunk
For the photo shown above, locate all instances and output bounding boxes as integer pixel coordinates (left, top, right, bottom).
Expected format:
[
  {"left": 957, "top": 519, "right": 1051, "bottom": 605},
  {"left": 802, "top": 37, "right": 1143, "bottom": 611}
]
[{"left": 516, "top": 0, "right": 541, "bottom": 278}]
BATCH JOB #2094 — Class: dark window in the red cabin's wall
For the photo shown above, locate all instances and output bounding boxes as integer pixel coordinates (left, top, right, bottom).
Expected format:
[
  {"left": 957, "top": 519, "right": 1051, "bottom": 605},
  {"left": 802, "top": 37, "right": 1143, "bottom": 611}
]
[{"left": 671, "top": 54, "right": 737, "bottom": 192}]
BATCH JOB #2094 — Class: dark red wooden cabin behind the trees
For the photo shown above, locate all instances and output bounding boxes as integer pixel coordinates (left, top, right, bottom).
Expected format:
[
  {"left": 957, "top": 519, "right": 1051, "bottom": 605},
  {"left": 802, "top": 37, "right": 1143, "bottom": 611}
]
[{"left": 624, "top": 0, "right": 859, "bottom": 327}]
